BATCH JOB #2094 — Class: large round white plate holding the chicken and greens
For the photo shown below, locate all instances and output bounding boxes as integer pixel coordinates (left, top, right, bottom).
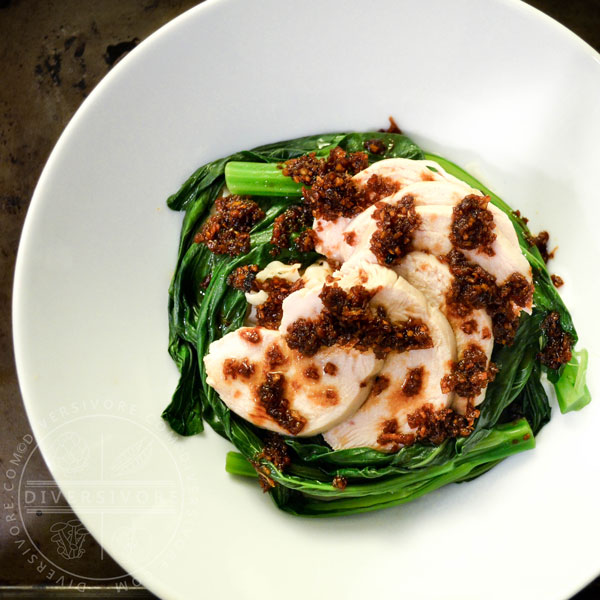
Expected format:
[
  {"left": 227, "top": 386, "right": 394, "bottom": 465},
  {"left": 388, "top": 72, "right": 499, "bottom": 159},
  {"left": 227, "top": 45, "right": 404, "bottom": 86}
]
[{"left": 14, "top": 0, "right": 600, "bottom": 600}]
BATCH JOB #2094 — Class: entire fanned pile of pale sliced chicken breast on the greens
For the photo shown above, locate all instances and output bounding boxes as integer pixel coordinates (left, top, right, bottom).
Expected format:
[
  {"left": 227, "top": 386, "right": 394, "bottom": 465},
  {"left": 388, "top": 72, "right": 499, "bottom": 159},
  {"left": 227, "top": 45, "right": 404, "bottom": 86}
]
[{"left": 204, "top": 159, "right": 532, "bottom": 451}]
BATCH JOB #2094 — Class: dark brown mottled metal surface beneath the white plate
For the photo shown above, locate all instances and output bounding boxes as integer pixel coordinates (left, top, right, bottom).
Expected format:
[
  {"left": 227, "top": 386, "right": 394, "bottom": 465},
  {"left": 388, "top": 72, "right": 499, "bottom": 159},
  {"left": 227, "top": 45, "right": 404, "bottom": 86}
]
[{"left": 0, "top": 0, "right": 600, "bottom": 600}]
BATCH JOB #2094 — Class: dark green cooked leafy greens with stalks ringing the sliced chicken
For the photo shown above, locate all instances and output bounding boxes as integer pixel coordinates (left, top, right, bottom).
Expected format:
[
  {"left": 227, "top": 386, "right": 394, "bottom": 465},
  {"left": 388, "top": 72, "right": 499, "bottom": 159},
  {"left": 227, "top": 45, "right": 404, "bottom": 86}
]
[{"left": 163, "top": 132, "right": 590, "bottom": 516}]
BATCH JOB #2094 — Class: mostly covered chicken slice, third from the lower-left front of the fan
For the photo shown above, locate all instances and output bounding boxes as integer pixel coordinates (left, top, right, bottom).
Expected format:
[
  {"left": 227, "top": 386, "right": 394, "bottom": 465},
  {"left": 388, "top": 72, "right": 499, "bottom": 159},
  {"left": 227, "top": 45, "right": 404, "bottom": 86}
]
[{"left": 394, "top": 252, "right": 494, "bottom": 414}]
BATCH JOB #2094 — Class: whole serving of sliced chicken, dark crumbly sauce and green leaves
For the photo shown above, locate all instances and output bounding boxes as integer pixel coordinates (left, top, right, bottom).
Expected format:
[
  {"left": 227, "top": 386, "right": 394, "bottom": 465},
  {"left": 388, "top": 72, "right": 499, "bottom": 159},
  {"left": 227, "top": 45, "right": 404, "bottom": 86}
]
[{"left": 163, "top": 128, "right": 590, "bottom": 517}]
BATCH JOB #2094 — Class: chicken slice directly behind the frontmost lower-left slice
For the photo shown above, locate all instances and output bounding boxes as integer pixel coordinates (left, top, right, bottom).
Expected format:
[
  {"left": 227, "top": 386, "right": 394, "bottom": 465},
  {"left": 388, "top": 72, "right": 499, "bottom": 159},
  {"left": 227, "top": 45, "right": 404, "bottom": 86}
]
[{"left": 280, "top": 263, "right": 456, "bottom": 451}]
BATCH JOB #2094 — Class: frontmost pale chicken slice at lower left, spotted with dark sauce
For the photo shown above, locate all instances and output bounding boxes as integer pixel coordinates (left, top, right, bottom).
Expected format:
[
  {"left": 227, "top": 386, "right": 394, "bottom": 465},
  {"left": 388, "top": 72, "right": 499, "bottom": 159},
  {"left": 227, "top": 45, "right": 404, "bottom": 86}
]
[{"left": 204, "top": 327, "right": 383, "bottom": 436}]
